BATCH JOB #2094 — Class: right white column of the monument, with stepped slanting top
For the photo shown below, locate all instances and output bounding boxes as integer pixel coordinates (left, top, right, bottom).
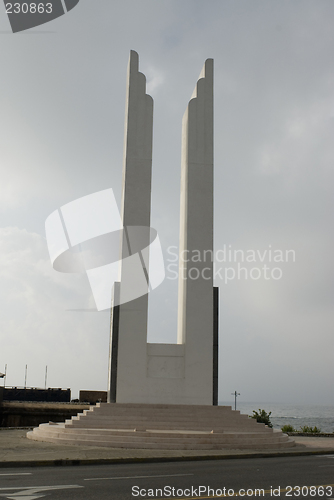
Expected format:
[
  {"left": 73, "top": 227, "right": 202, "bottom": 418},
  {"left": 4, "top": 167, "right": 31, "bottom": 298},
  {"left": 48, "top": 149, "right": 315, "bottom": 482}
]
[{"left": 178, "top": 59, "right": 213, "bottom": 404}]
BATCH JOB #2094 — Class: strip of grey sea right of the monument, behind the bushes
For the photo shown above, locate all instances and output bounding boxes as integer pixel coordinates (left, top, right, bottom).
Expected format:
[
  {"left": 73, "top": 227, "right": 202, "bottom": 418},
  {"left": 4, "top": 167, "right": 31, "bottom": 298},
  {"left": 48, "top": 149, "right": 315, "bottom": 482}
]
[{"left": 219, "top": 401, "right": 334, "bottom": 433}]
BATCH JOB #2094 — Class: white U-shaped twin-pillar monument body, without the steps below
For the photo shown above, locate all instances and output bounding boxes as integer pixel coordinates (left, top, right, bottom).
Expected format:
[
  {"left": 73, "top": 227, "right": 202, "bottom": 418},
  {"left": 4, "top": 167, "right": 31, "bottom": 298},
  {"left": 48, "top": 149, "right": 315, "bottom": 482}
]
[{"left": 108, "top": 51, "right": 218, "bottom": 405}]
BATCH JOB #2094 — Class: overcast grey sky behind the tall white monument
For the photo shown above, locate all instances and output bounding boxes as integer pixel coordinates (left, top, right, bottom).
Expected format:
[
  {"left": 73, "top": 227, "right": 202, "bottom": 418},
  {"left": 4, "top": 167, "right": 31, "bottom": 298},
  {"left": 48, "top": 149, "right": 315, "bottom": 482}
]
[{"left": 0, "top": 0, "right": 334, "bottom": 405}]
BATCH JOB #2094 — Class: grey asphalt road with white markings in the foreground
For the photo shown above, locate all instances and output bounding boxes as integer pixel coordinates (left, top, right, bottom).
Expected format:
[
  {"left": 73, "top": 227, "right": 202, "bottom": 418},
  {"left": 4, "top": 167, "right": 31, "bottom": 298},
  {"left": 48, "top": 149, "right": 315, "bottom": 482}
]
[{"left": 0, "top": 455, "right": 334, "bottom": 500}]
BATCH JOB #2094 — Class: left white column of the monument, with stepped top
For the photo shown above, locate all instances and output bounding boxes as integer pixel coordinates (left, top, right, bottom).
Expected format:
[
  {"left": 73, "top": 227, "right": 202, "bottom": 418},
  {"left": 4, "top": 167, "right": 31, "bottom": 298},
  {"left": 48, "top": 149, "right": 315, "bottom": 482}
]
[{"left": 116, "top": 51, "right": 153, "bottom": 403}]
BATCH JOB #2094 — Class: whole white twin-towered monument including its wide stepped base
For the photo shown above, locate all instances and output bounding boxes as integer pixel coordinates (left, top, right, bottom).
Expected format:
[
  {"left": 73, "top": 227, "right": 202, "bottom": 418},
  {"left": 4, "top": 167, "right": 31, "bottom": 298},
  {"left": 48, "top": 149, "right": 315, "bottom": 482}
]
[{"left": 27, "top": 51, "right": 295, "bottom": 450}]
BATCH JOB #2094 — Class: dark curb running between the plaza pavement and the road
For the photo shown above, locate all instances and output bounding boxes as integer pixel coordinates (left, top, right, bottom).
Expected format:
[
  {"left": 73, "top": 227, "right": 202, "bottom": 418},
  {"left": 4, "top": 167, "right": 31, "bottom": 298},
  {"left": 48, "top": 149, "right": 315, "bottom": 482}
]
[{"left": 0, "top": 449, "right": 334, "bottom": 468}]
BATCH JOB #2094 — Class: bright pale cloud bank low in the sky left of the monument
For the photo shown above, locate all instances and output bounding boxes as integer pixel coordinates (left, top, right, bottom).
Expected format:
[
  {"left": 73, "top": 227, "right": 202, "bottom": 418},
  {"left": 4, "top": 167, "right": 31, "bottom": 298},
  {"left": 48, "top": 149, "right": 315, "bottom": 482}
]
[{"left": 0, "top": 227, "right": 109, "bottom": 397}]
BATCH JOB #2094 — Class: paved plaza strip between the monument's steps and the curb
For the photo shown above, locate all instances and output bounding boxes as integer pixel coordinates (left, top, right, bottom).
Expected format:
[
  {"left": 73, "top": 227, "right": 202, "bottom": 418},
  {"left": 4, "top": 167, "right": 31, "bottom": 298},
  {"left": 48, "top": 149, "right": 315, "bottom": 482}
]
[{"left": 0, "top": 428, "right": 334, "bottom": 467}]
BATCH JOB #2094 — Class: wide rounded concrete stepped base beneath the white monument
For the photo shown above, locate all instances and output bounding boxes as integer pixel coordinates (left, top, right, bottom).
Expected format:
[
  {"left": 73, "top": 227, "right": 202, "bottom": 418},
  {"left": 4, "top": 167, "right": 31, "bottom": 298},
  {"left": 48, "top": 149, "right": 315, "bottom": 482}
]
[{"left": 27, "top": 403, "right": 295, "bottom": 450}]
